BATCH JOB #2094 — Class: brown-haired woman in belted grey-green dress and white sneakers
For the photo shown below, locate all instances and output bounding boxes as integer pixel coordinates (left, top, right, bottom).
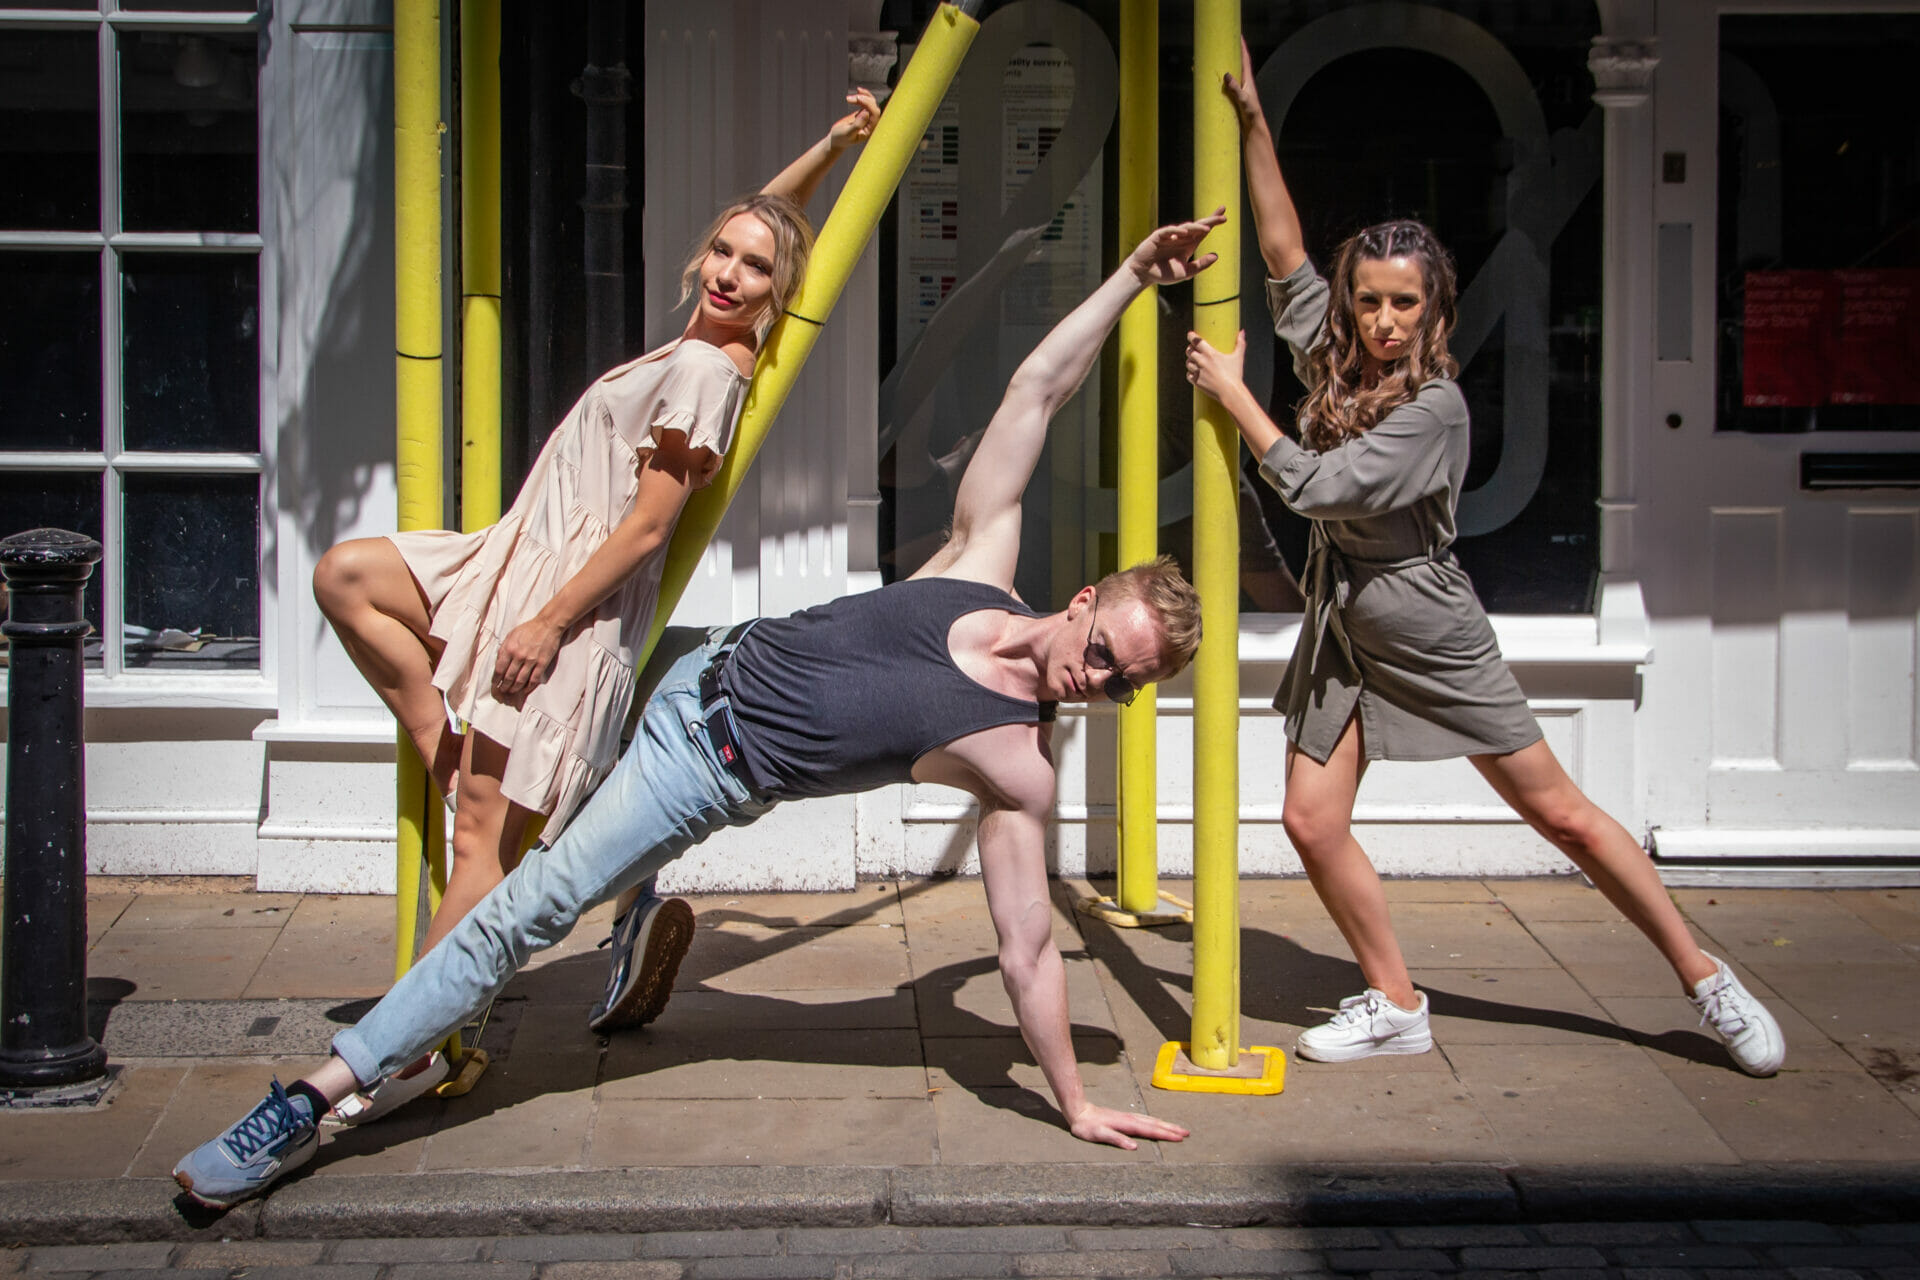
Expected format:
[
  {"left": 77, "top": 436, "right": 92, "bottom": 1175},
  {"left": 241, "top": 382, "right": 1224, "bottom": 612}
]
[{"left": 1187, "top": 52, "right": 1786, "bottom": 1075}]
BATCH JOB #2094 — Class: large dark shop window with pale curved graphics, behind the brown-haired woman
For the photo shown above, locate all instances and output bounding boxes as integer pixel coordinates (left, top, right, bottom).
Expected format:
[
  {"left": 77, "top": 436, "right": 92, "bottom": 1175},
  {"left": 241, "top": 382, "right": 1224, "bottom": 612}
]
[{"left": 879, "top": 0, "right": 1603, "bottom": 612}]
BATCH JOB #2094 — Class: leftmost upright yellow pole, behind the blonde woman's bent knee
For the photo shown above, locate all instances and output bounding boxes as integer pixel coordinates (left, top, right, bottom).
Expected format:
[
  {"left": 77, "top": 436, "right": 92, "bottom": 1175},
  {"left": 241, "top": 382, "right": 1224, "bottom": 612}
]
[{"left": 394, "top": 0, "right": 444, "bottom": 979}]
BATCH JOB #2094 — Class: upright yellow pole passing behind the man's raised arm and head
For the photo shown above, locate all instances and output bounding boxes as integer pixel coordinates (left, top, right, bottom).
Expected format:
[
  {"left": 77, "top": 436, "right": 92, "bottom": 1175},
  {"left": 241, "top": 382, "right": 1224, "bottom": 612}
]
[{"left": 1079, "top": 0, "right": 1192, "bottom": 929}]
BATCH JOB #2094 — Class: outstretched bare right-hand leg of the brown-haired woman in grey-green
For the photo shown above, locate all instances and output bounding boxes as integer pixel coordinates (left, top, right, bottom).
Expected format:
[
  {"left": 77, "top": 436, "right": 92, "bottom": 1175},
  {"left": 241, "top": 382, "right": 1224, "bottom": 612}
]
[{"left": 1473, "top": 743, "right": 1715, "bottom": 996}]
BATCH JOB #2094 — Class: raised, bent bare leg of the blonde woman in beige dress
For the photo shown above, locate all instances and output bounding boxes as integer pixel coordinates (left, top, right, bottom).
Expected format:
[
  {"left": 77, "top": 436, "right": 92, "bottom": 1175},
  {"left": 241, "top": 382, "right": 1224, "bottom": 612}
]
[{"left": 313, "top": 537, "right": 461, "bottom": 794}]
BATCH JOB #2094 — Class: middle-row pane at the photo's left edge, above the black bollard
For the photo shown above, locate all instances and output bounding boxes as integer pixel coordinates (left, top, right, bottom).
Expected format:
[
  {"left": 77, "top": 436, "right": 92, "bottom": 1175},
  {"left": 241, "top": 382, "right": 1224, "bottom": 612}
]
[{"left": 0, "top": 253, "right": 100, "bottom": 449}]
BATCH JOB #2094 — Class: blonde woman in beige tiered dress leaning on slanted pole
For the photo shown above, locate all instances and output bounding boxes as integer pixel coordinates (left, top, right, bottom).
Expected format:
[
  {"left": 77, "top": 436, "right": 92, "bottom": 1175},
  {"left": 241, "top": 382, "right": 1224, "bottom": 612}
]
[{"left": 313, "top": 90, "right": 879, "bottom": 1123}]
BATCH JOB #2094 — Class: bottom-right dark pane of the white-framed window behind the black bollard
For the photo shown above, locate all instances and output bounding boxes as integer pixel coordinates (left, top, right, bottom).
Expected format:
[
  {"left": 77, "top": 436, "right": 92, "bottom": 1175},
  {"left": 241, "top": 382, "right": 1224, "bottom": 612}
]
[{"left": 123, "top": 472, "right": 259, "bottom": 668}]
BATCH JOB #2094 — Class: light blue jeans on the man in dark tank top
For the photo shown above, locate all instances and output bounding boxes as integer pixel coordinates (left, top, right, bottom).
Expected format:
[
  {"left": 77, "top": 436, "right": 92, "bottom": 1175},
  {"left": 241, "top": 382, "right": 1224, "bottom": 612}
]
[{"left": 334, "top": 629, "right": 774, "bottom": 1084}]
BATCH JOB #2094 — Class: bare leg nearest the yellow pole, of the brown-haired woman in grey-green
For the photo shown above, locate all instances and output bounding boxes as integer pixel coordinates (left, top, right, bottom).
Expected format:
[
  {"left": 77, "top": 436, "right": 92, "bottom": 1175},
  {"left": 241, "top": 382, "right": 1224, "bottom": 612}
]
[{"left": 1281, "top": 716, "right": 1419, "bottom": 1009}]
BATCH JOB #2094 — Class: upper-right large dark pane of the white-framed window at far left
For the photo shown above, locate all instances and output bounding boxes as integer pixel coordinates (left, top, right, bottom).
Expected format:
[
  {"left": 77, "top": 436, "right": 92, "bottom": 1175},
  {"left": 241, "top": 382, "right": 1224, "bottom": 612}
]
[{"left": 119, "top": 30, "right": 259, "bottom": 230}]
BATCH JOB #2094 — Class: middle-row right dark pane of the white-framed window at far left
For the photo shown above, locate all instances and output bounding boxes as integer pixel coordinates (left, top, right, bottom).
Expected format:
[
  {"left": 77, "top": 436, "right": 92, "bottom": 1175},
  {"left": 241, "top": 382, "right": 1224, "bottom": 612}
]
[{"left": 121, "top": 253, "right": 259, "bottom": 453}]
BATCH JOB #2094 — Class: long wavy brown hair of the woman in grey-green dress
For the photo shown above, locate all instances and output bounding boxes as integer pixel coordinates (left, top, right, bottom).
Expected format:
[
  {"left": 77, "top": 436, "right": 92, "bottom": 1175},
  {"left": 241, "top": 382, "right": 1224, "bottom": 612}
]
[{"left": 1296, "top": 219, "right": 1459, "bottom": 451}]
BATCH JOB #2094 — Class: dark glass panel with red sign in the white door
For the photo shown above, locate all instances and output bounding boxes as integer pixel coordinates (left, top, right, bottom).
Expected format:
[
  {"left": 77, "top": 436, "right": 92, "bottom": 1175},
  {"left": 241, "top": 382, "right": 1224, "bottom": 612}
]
[{"left": 1716, "top": 13, "right": 1920, "bottom": 432}]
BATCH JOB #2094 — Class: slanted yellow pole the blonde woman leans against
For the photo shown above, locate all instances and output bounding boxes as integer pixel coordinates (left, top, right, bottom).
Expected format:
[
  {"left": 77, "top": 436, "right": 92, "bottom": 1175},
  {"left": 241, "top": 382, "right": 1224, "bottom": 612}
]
[{"left": 639, "top": 4, "right": 979, "bottom": 662}]
